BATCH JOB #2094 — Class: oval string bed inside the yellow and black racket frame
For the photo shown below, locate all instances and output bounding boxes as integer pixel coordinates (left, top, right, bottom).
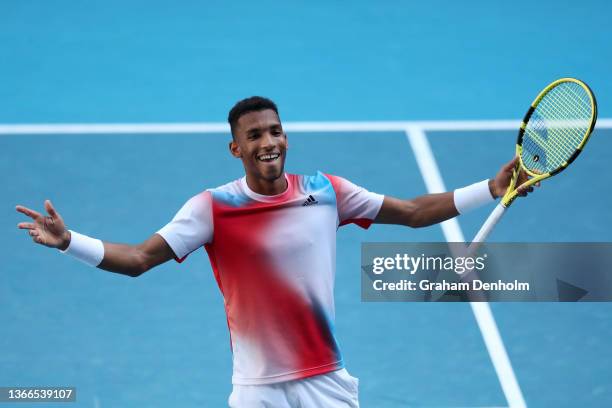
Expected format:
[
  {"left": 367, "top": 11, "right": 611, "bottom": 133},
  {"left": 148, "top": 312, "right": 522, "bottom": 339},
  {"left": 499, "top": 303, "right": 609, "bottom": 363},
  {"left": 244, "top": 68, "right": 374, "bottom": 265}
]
[{"left": 521, "top": 82, "right": 593, "bottom": 173}]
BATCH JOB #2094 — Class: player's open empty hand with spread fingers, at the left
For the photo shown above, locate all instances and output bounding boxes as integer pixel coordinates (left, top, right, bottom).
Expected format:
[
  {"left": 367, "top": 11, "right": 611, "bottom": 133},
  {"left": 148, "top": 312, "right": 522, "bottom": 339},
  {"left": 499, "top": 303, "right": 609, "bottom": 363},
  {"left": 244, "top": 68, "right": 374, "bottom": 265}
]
[{"left": 15, "top": 200, "right": 70, "bottom": 250}]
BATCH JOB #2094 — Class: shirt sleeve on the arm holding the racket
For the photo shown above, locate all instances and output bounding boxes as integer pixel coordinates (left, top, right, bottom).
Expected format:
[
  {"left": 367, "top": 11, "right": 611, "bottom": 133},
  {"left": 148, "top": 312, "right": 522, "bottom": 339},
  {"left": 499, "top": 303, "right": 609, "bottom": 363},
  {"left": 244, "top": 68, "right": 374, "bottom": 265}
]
[{"left": 326, "top": 175, "right": 385, "bottom": 228}]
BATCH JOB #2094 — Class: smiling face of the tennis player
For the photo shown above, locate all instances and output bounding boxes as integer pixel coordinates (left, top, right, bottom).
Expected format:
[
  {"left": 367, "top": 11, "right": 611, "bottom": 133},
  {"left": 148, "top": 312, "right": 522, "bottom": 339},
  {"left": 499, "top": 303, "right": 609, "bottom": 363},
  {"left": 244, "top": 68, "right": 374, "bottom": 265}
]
[{"left": 230, "top": 109, "right": 287, "bottom": 181}]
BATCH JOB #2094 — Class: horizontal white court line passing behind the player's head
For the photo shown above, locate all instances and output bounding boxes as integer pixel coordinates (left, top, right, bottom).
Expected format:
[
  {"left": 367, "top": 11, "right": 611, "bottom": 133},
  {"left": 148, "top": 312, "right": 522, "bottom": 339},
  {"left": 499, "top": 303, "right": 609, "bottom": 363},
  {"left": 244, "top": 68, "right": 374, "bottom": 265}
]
[{"left": 0, "top": 119, "right": 612, "bottom": 135}]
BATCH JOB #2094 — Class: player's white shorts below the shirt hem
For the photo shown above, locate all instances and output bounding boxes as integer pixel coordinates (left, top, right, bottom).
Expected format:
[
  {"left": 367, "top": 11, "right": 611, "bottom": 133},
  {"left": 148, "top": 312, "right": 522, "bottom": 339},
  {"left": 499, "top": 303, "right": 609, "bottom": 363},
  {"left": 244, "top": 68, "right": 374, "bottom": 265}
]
[{"left": 229, "top": 368, "right": 359, "bottom": 408}]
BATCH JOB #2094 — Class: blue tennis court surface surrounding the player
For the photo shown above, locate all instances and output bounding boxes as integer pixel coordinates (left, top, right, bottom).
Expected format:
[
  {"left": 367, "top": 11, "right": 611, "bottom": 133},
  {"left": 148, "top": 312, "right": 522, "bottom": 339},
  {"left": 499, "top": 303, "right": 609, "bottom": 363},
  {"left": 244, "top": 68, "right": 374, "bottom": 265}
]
[{"left": 0, "top": 1, "right": 612, "bottom": 408}]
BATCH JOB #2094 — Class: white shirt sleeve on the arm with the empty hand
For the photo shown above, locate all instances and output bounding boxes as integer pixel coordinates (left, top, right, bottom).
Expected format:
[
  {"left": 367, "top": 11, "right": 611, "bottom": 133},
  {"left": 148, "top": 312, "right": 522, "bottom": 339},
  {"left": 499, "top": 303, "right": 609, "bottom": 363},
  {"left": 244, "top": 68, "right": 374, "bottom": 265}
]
[{"left": 157, "top": 191, "right": 213, "bottom": 262}]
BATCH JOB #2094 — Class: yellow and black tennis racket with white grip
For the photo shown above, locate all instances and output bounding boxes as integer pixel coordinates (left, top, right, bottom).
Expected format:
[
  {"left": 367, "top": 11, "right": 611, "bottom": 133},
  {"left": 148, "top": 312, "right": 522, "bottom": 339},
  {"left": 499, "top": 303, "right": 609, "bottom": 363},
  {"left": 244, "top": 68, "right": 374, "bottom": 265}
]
[{"left": 468, "top": 78, "right": 597, "bottom": 254}]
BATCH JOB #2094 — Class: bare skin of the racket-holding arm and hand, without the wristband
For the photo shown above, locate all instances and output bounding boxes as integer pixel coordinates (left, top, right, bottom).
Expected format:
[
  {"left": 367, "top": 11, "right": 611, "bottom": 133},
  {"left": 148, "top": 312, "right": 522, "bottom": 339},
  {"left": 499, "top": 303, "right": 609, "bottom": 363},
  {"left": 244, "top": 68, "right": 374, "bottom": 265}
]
[{"left": 374, "top": 157, "right": 533, "bottom": 228}]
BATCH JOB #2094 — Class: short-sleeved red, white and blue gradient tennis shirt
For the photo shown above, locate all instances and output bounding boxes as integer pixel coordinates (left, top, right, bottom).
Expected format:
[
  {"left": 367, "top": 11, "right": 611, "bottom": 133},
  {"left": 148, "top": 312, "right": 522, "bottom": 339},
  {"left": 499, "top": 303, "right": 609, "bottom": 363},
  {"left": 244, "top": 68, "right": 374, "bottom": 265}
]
[{"left": 157, "top": 172, "right": 383, "bottom": 385}]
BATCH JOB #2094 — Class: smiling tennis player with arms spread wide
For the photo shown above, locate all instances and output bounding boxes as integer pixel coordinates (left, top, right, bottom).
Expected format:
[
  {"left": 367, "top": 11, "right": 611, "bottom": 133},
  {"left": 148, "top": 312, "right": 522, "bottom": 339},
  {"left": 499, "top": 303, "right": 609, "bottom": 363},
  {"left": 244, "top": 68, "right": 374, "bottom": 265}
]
[{"left": 17, "top": 97, "right": 528, "bottom": 407}]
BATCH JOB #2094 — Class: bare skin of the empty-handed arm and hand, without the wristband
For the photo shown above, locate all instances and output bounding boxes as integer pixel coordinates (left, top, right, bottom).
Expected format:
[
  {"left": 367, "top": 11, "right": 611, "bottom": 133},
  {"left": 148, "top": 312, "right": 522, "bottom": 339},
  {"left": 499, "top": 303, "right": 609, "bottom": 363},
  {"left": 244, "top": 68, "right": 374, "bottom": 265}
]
[{"left": 16, "top": 200, "right": 174, "bottom": 276}]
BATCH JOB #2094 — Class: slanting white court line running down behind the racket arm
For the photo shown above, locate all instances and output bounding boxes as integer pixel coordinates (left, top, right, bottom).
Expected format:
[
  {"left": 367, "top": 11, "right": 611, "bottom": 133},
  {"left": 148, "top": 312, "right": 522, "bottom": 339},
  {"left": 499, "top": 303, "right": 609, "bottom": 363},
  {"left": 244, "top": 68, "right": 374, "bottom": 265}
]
[{"left": 406, "top": 126, "right": 527, "bottom": 408}]
